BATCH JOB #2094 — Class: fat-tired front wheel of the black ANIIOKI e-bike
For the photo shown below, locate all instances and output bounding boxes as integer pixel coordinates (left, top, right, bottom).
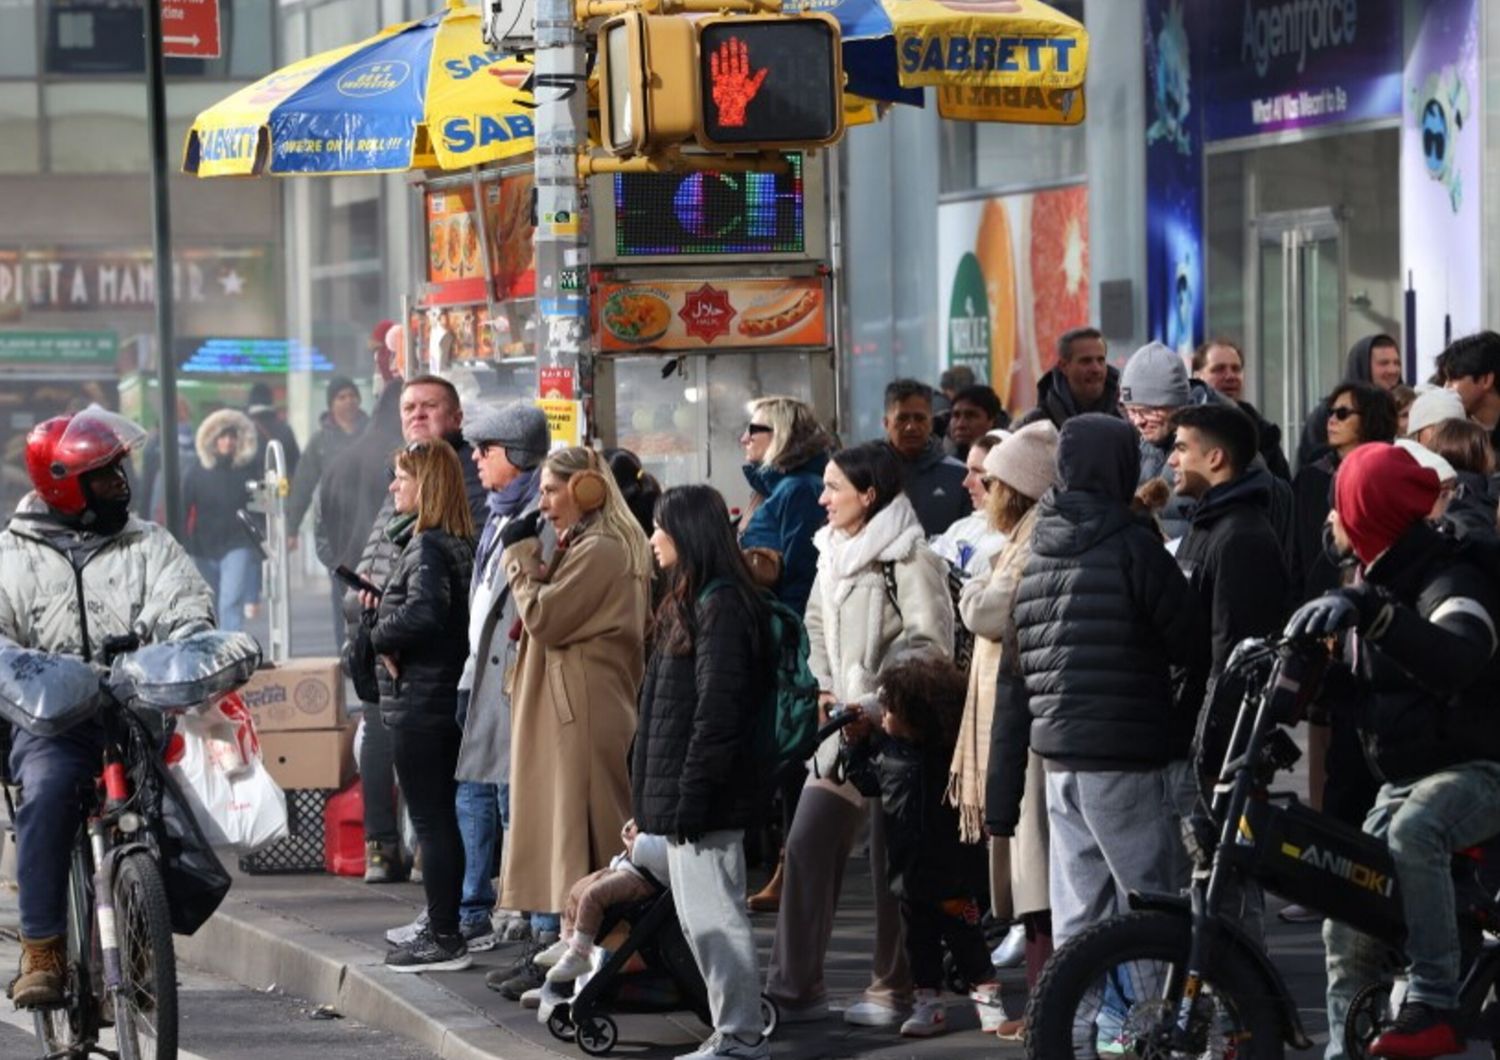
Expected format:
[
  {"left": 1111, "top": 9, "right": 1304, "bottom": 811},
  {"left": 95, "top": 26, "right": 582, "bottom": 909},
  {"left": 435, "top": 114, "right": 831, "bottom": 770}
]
[{"left": 1026, "top": 912, "right": 1284, "bottom": 1060}]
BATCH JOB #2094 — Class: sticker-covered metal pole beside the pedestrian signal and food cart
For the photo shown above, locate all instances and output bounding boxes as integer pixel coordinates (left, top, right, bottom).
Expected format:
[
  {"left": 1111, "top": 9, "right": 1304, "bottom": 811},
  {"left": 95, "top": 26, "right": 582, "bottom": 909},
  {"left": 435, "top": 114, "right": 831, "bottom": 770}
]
[{"left": 534, "top": 0, "right": 594, "bottom": 444}]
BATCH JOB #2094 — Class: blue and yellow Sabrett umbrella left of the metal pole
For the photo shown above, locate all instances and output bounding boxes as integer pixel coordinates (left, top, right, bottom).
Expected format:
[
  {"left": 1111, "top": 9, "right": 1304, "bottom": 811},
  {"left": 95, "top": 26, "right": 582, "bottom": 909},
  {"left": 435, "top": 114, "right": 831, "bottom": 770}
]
[{"left": 183, "top": 0, "right": 533, "bottom": 177}]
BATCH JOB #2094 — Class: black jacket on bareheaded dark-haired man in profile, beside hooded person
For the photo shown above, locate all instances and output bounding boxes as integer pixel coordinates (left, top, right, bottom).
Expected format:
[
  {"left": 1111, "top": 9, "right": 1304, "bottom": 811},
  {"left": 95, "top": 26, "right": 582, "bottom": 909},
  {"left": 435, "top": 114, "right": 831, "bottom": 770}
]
[{"left": 1178, "top": 468, "right": 1292, "bottom": 676}]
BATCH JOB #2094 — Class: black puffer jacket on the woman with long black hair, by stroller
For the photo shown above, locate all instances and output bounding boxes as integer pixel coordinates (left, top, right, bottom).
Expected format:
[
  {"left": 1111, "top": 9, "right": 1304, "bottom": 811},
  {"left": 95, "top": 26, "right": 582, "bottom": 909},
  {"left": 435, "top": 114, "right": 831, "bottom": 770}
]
[{"left": 630, "top": 588, "right": 770, "bottom": 835}]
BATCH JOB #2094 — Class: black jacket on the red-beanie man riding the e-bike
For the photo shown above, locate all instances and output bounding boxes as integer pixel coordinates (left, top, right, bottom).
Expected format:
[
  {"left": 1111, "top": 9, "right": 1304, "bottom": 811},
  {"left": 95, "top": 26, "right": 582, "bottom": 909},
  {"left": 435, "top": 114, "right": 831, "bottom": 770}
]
[{"left": 1358, "top": 522, "right": 1500, "bottom": 781}]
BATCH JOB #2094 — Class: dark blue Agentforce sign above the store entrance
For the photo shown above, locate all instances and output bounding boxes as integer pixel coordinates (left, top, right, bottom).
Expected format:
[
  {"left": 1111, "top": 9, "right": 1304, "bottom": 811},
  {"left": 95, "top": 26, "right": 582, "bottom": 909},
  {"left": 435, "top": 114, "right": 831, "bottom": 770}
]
[{"left": 1190, "top": 0, "right": 1403, "bottom": 141}]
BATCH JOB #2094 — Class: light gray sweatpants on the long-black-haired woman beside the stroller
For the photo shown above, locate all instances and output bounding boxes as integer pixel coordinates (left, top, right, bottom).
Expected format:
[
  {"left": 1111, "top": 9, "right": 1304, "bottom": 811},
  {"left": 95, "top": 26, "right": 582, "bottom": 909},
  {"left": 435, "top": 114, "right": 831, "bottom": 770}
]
[{"left": 666, "top": 829, "right": 764, "bottom": 1042}]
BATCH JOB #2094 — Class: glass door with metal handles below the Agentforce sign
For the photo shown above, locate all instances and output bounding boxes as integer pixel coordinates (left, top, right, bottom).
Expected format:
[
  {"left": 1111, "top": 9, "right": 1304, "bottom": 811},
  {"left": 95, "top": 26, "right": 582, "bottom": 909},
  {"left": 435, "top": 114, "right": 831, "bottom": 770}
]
[{"left": 1254, "top": 207, "right": 1349, "bottom": 457}]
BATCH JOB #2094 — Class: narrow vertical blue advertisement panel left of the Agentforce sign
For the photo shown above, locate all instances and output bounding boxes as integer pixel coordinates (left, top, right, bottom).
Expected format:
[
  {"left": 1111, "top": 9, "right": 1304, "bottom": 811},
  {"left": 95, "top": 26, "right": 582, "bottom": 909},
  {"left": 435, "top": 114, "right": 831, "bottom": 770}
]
[{"left": 1145, "top": 0, "right": 1205, "bottom": 354}]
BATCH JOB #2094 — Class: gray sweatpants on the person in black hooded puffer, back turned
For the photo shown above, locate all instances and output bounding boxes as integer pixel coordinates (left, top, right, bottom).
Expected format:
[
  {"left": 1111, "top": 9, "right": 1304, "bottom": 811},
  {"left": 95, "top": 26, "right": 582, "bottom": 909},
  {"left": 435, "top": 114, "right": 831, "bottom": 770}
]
[{"left": 1047, "top": 769, "right": 1182, "bottom": 948}]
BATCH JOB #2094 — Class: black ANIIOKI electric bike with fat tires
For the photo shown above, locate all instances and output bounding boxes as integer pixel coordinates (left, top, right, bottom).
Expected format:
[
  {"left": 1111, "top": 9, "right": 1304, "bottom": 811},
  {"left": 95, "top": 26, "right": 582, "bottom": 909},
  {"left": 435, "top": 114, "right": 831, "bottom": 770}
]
[{"left": 1026, "top": 640, "right": 1500, "bottom": 1060}]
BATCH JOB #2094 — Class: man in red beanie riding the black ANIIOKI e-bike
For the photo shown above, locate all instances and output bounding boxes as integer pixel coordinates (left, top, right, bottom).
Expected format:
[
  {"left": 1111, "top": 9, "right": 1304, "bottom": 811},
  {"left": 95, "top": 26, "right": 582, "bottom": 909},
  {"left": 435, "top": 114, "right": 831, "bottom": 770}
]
[{"left": 1287, "top": 442, "right": 1500, "bottom": 1060}]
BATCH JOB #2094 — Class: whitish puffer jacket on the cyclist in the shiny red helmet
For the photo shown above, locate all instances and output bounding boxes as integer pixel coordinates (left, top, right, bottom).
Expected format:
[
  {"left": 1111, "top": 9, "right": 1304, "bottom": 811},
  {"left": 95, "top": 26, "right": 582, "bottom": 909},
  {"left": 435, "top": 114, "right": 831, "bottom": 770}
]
[{"left": 0, "top": 493, "right": 215, "bottom": 657}]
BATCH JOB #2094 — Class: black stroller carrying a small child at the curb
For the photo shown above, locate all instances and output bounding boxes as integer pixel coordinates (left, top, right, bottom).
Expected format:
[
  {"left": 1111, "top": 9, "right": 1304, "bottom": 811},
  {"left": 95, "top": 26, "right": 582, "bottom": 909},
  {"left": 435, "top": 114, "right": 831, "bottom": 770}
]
[{"left": 543, "top": 874, "right": 777, "bottom": 1057}]
